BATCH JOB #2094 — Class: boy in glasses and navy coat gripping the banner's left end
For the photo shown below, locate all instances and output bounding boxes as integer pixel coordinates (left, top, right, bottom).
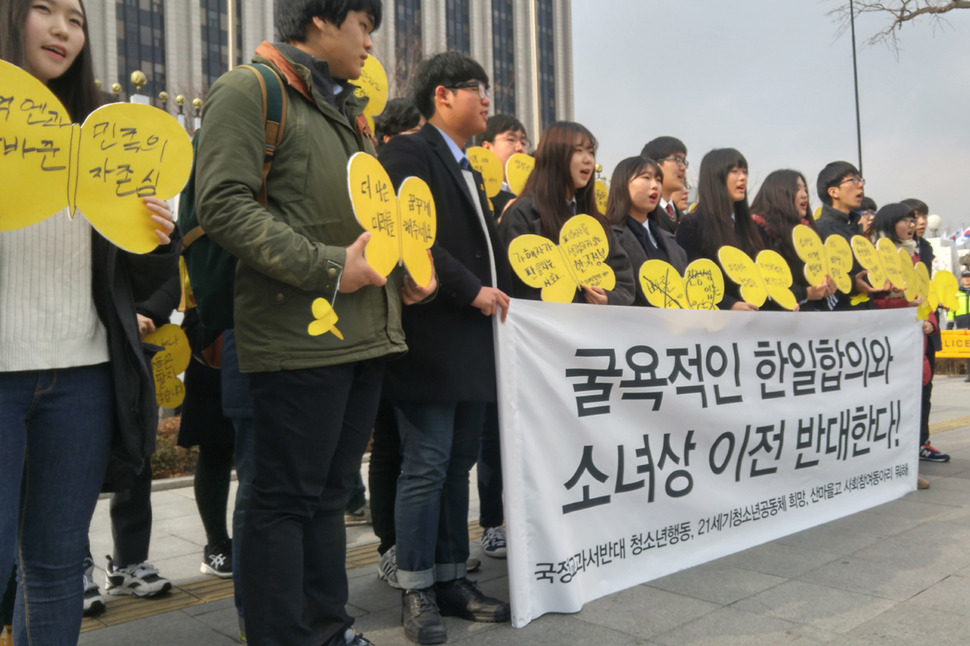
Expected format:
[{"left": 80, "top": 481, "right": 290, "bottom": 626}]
[{"left": 380, "top": 52, "right": 511, "bottom": 644}]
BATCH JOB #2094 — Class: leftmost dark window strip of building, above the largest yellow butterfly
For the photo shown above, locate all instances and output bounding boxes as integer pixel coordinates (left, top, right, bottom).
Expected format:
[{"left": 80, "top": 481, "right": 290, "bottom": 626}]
[{"left": 115, "top": 0, "right": 165, "bottom": 101}]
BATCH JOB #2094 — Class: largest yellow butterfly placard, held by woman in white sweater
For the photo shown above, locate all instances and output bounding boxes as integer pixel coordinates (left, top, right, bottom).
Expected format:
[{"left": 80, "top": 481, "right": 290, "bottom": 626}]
[{"left": 0, "top": 61, "right": 192, "bottom": 253}]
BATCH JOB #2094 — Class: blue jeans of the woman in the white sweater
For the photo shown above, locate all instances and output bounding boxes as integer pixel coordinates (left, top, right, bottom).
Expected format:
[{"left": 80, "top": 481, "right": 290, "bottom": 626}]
[{"left": 0, "top": 363, "right": 114, "bottom": 644}]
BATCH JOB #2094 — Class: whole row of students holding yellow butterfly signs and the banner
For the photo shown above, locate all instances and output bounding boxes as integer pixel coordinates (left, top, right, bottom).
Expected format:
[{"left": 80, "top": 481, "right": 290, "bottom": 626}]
[{"left": 0, "top": 0, "right": 970, "bottom": 646}]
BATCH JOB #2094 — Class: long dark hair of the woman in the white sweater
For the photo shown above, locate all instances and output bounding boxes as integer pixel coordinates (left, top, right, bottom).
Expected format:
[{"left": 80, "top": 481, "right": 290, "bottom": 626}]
[{"left": 0, "top": 0, "right": 101, "bottom": 122}]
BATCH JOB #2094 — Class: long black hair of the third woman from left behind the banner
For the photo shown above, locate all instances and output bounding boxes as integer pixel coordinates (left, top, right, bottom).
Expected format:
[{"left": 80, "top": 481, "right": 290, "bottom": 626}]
[{"left": 697, "top": 148, "right": 764, "bottom": 258}]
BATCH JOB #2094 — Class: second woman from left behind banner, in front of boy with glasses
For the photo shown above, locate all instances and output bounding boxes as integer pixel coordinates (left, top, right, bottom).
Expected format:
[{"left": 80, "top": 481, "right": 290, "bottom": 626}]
[{"left": 606, "top": 157, "right": 687, "bottom": 305}]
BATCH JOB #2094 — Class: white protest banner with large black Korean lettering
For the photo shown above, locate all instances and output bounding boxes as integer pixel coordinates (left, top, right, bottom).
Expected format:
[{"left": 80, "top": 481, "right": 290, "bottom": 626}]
[{"left": 496, "top": 299, "right": 923, "bottom": 627}]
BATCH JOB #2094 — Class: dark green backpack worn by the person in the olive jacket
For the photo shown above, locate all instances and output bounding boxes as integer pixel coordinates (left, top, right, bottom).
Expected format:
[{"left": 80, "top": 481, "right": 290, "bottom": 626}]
[{"left": 178, "top": 64, "right": 286, "bottom": 330}]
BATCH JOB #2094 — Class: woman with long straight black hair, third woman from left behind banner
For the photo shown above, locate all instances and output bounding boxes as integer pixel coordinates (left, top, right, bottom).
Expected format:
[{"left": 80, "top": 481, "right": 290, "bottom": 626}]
[{"left": 677, "top": 148, "right": 764, "bottom": 310}]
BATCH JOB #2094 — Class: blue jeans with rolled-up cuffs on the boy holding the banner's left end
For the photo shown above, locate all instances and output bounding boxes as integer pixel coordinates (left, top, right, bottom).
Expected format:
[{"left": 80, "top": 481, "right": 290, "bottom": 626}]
[{"left": 394, "top": 402, "right": 485, "bottom": 590}]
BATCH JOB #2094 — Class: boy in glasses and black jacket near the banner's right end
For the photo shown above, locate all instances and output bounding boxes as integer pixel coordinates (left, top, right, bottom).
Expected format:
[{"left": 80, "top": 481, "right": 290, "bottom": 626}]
[{"left": 815, "top": 161, "right": 883, "bottom": 310}]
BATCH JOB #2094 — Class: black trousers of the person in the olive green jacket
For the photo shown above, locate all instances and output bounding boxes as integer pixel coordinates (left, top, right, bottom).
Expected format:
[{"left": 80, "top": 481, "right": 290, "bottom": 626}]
[{"left": 240, "top": 360, "right": 384, "bottom": 646}]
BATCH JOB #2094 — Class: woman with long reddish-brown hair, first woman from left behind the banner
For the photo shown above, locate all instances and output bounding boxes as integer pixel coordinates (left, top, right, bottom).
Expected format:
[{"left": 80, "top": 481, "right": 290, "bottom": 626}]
[{"left": 498, "top": 121, "right": 634, "bottom": 305}]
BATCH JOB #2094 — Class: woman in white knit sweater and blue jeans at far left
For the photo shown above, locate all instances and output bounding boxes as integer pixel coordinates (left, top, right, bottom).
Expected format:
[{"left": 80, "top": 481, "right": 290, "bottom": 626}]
[{"left": 0, "top": 0, "right": 181, "bottom": 644}]
